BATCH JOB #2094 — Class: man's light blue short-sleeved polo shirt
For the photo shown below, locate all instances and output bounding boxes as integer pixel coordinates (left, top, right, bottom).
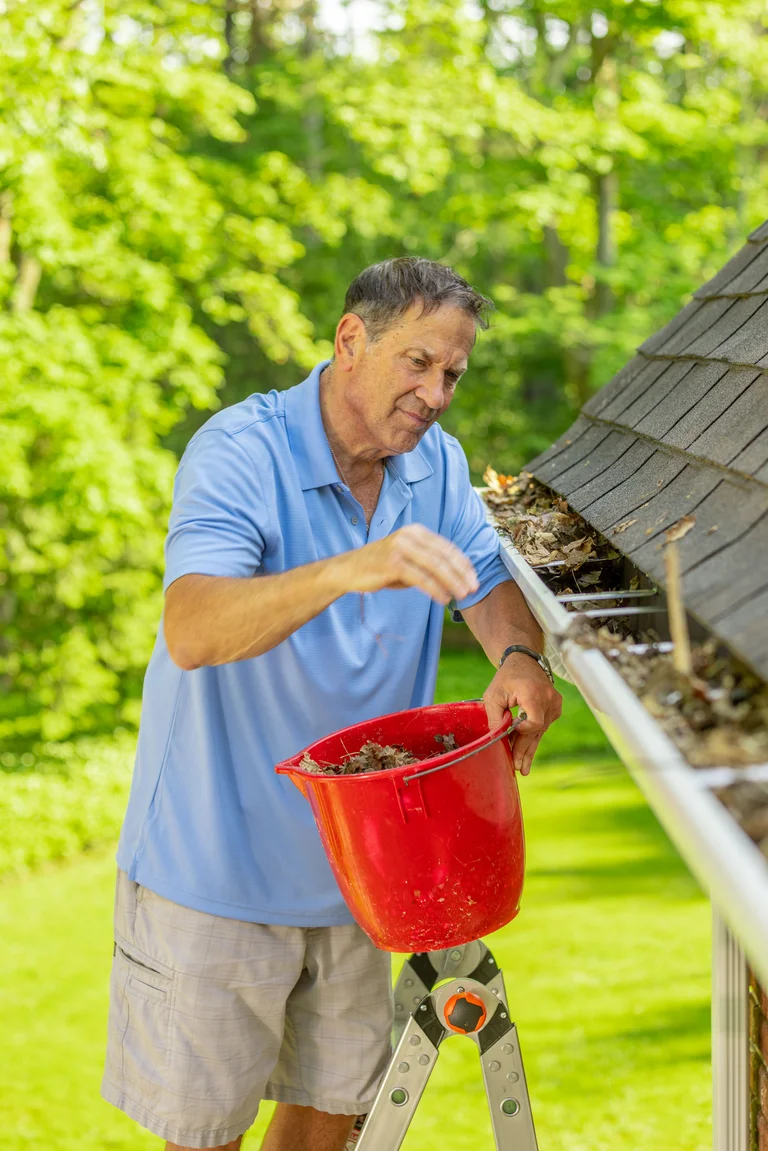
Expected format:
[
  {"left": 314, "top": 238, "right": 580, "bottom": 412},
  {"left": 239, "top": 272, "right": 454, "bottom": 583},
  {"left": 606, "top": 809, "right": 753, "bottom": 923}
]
[{"left": 117, "top": 363, "right": 509, "bottom": 927}]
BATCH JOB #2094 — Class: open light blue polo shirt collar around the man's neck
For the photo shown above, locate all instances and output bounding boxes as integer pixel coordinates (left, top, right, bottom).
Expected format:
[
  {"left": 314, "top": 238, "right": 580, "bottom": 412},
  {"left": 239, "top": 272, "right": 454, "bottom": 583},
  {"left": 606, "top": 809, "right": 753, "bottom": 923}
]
[{"left": 286, "top": 360, "right": 434, "bottom": 491}]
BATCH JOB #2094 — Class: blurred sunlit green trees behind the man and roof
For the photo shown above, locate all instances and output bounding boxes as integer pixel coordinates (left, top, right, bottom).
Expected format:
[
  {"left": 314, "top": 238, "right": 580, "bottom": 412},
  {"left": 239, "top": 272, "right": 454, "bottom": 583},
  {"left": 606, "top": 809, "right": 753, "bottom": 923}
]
[{"left": 0, "top": 0, "right": 768, "bottom": 750}]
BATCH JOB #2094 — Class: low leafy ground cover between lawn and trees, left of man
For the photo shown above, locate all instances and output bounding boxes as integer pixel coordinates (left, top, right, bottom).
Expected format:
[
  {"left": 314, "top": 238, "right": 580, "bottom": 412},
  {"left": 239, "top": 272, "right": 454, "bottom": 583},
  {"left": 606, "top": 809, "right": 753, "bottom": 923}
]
[{"left": 0, "top": 734, "right": 135, "bottom": 879}]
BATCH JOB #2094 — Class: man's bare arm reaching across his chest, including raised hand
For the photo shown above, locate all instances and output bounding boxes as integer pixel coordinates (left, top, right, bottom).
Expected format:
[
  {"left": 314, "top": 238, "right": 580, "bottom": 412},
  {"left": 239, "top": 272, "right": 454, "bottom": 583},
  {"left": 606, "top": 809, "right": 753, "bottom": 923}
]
[{"left": 164, "top": 524, "right": 478, "bottom": 671}]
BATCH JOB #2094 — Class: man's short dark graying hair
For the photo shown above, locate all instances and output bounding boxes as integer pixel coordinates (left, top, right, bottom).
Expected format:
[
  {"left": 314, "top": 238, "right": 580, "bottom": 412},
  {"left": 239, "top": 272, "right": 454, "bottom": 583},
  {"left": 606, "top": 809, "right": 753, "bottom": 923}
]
[{"left": 344, "top": 256, "right": 494, "bottom": 341}]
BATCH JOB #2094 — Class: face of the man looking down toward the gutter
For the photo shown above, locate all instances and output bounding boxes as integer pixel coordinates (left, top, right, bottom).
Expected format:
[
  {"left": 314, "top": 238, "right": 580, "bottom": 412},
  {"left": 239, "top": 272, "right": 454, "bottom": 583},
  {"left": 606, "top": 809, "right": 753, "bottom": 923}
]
[{"left": 345, "top": 303, "right": 476, "bottom": 456}]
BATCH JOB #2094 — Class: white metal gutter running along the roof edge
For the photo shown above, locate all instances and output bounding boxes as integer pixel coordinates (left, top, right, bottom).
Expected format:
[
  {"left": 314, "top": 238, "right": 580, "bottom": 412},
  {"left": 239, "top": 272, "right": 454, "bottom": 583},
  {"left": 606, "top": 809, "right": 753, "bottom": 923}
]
[{"left": 489, "top": 517, "right": 768, "bottom": 986}]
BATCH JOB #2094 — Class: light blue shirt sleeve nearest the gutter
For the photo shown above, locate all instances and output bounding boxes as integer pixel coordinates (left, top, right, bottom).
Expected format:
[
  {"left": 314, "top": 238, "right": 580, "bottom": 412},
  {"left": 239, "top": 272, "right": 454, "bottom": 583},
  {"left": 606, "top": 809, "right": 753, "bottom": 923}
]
[{"left": 446, "top": 435, "right": 512, "bottom": 622}]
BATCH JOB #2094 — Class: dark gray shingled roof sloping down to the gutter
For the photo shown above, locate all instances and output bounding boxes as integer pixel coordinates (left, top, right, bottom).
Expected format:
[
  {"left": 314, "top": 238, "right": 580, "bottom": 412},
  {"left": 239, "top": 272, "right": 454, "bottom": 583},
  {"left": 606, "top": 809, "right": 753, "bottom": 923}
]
[{"left": 527, "top": 221, "right": 768, "bottom": 679}]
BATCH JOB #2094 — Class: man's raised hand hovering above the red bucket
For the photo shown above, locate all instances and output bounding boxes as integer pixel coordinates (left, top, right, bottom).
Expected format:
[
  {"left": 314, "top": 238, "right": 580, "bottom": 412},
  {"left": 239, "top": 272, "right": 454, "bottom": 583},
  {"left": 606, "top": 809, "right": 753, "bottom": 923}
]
[{"left": 336, "top": 524, "right": 478, "bottom": 604}]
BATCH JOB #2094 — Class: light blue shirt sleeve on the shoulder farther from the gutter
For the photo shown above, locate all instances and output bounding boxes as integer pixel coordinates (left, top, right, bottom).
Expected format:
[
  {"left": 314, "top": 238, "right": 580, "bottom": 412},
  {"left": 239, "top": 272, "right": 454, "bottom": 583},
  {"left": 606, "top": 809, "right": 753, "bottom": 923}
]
[{"left": 162, "top": 428, "right": 268, "bottom": 590}]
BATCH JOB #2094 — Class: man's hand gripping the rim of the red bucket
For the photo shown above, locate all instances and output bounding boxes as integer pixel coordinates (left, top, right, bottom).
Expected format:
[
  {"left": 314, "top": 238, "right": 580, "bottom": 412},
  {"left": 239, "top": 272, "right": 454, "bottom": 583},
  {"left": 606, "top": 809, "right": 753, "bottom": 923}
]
[{"left": 482, "top": 651, "right": 563, "bottom": 776}]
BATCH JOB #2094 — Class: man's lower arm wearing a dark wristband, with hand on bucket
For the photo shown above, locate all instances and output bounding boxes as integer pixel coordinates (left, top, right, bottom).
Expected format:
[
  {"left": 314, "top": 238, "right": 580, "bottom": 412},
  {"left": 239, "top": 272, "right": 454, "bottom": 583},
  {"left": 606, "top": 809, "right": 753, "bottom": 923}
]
[{"left": 462, "top": 568, "right": 563, "bottom": 776}]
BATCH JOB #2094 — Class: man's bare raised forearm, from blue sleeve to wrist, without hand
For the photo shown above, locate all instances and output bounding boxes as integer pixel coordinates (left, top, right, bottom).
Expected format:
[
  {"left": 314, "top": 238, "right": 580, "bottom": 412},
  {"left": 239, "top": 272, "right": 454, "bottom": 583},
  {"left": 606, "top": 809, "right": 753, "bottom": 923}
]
[{"left": 164, "top": 556, "right": 349, "bottom": 671}]
